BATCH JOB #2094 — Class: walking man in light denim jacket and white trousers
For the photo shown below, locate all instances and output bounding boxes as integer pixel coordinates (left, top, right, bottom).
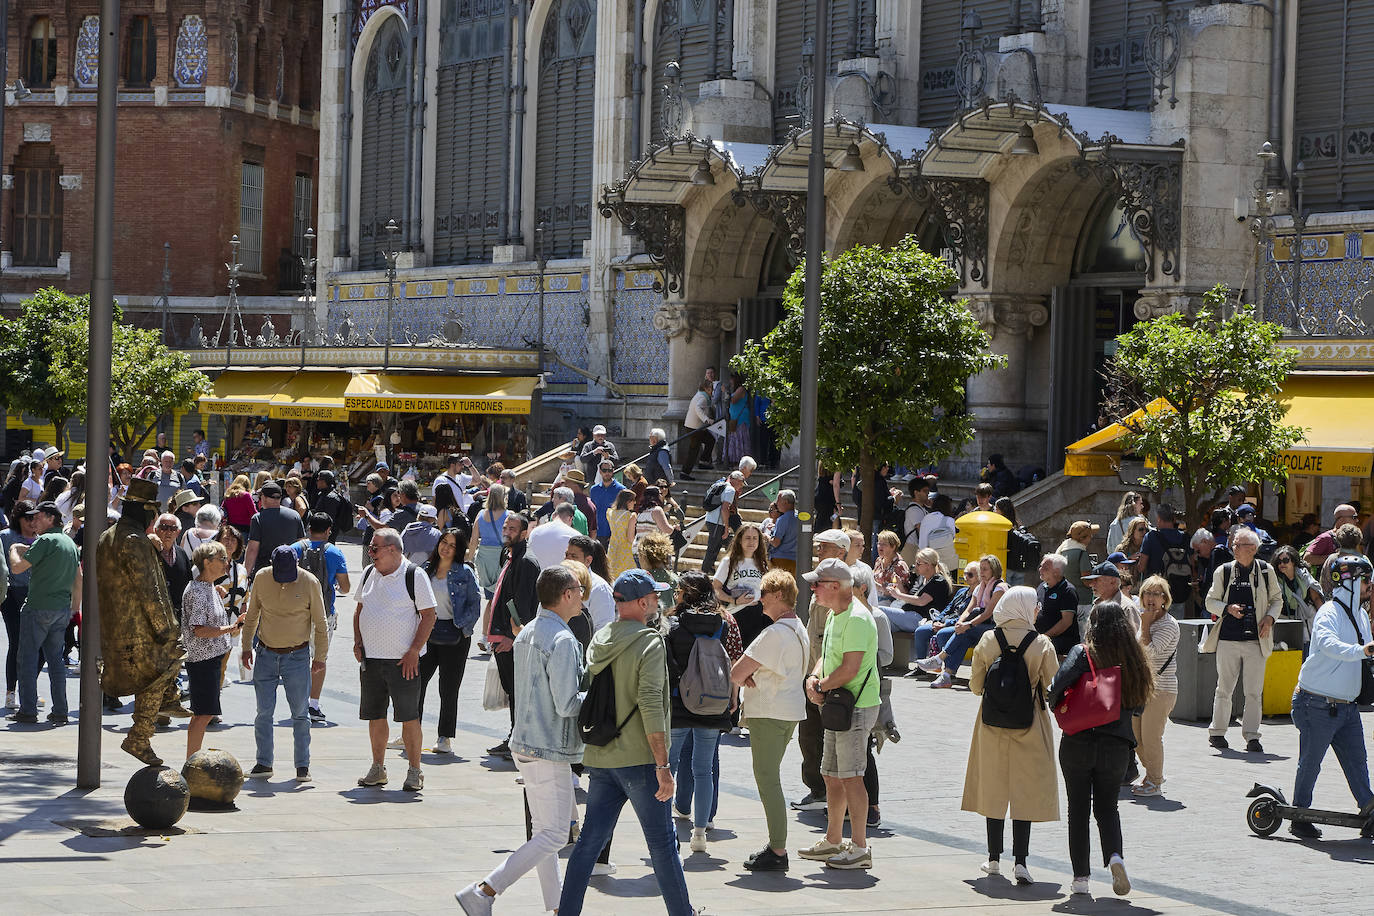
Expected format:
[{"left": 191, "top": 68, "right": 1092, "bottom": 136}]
[{"left": 455, "top": 566, "right": 585, "bottom": 916}]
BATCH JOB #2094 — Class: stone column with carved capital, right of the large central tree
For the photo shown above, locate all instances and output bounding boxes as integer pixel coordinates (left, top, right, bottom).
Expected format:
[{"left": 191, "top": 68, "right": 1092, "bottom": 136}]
[{"left": 959, "top": 291, "right": 1050, "bottom": 477}]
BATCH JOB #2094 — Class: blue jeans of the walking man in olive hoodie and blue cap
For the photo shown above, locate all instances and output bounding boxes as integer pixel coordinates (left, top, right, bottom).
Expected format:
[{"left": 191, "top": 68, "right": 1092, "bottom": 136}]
[{"left": 558, "top": 764, "right": 692, "bottom": 916}]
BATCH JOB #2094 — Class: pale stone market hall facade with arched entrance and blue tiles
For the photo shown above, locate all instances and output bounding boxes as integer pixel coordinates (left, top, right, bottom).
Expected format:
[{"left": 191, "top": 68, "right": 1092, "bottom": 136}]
[{"left": 319, "top": 0, "right": 1357, "bottom": 478}]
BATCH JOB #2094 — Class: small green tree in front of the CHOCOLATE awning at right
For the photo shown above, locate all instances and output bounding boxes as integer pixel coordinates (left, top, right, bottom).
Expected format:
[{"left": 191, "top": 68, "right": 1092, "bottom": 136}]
[{"left": 1106, "top": 286, "right": 1304, "bottom": 530}]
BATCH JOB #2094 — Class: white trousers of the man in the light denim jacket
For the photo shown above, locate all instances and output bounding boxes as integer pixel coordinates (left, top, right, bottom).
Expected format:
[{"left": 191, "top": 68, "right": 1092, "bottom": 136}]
[{"left": 486, "top": 754, "right": 573, "bottom": 911}]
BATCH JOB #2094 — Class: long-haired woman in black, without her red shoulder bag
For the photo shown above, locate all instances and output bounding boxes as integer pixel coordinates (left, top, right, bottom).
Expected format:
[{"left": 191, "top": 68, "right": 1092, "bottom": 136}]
[{"left": 1048, "top": 602, "right": 1154, "bottom": 895}]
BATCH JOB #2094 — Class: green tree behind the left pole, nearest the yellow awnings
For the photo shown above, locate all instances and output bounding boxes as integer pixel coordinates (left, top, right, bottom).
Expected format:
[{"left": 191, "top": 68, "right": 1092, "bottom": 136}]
[{"left": 49, "top": 324, "right": 210, "bottom": 466}]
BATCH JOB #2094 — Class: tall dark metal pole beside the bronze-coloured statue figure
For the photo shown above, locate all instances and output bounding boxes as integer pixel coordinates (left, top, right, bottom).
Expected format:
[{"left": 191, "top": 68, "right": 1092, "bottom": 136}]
[{"left": 77, "top": 0, "right": 120, "bottom": 788}]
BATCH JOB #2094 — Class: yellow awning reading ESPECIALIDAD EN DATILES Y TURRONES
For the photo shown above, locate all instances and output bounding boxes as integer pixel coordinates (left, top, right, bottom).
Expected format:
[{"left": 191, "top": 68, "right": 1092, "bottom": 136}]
[{"left": 344, "top": 372, "right": 539, "bottom": 413}]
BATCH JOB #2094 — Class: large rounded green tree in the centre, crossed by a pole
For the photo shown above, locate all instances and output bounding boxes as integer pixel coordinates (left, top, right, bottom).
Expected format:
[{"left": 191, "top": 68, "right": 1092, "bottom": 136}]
[{"left": 731, "top": 236, "right": 1006, "bottom": 541}]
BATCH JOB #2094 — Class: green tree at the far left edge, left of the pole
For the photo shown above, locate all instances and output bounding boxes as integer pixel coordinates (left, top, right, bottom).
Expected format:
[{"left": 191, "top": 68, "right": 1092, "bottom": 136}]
[{"left": 0, "top": 287, "right": 120, "bottom": 449}]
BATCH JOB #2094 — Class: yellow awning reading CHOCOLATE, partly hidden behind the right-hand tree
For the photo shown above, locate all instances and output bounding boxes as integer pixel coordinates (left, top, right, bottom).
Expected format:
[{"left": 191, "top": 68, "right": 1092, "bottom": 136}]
[{"left": 1063, "top": 372, "right": 1374, "bottom": 477}]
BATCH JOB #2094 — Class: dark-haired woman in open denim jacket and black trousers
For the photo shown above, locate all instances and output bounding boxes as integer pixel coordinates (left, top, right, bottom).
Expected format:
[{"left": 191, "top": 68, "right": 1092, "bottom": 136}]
[{"left": 420, "top": 527, "right": 482, "bottom": 754}]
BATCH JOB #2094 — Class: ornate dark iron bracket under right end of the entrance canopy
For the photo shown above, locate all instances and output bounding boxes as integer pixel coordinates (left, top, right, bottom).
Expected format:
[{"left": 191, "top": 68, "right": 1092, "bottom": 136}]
[{"left": 1079, "top": 150, "right": 1183, "bottom": 280}]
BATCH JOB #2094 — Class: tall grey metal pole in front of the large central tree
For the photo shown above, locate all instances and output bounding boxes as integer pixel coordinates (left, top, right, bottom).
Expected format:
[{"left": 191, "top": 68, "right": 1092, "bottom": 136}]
[{"left": 797, "top": 0, "right": 830, "bottom": 610}]
